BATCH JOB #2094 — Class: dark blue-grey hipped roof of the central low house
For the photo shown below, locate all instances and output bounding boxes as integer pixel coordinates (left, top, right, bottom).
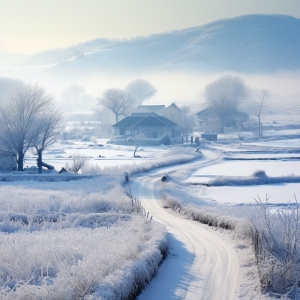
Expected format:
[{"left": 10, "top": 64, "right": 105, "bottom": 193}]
[{"left": 112, "top": 113, "right": 177, "bottom": 128}]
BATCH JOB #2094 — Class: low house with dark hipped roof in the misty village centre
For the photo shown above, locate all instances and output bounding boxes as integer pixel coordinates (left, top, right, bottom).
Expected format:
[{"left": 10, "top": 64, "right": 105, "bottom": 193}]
[{"left": 112, "top": 112, "right": 177, "bottom": 139}]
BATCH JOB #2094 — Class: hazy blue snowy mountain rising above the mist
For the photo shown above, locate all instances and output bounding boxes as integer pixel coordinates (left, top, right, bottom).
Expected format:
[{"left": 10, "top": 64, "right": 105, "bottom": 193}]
[{"left": 7, "top": 15, "right": 300, "bottom": 74}]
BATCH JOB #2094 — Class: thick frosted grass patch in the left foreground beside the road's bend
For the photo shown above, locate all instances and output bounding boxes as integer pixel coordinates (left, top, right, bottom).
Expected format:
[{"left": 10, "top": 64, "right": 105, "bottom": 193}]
[{"left": 0, "top": 216, "right": 167, "bottom": 299}]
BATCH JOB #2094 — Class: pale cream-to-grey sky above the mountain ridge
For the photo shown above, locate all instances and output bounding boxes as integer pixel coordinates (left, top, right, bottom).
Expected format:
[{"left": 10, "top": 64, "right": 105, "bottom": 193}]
[{"left": 0, "top": 0, "right": 300, "bottom": 54}]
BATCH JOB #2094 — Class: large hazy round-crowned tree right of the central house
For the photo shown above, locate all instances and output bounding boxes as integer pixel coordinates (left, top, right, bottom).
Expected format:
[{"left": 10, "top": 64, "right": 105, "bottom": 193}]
[{"left": 204, "top": 75, "right": 250, "bottom": 133}]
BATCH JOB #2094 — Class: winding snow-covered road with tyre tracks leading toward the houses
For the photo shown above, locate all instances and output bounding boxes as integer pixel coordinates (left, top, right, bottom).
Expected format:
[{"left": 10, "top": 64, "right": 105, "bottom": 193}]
[{"left": 131, "top": 150, "right": 239, "bottom": 300}]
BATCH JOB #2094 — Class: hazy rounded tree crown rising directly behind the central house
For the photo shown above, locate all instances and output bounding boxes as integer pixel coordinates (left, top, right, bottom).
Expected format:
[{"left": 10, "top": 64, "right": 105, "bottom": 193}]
[{"left": 125, "top": 79, "right": 157, "bottom": 104}]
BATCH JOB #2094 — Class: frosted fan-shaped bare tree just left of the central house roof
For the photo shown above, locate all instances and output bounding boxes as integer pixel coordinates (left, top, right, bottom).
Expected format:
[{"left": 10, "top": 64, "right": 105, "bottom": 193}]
[{"left": 99, "top": 88, "right": 135, "bottom": 122}]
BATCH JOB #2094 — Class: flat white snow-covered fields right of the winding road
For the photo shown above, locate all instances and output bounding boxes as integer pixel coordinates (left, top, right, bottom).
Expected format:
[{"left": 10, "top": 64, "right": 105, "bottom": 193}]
[{"left": 185, "top": 139, "right": 300, "bottom": 205}]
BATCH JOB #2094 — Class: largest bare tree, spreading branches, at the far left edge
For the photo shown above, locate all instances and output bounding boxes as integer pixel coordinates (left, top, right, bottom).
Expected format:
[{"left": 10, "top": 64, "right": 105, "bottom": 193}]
[{"left": 0, "top": 84, "right": 53, "bottom": 171}]
